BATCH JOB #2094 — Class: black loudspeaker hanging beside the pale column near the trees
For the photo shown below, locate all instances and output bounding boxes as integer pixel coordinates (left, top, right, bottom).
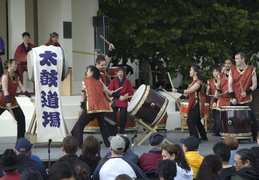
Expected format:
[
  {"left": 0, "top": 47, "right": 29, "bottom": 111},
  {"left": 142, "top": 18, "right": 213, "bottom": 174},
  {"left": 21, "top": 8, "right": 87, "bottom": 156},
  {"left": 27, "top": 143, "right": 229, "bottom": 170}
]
[{"left": 93, "top": 16, "right": 109, "bottom": 54}]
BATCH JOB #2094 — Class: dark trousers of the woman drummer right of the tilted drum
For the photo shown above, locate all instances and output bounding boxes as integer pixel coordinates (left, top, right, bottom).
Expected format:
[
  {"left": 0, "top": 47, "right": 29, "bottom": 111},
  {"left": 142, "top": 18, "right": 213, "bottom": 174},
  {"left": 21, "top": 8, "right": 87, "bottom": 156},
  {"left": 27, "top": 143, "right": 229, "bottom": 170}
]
[{"left": 187, "top": 104, "right": 207, "bottom": 139}]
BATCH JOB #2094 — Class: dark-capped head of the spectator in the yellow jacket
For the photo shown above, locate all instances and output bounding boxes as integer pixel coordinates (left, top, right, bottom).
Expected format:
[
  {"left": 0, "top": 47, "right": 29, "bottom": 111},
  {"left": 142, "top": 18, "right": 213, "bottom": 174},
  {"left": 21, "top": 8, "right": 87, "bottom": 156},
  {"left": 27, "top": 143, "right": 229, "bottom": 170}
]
[{"left": 180, "top": 136, "right": 200, "bottom": 152}]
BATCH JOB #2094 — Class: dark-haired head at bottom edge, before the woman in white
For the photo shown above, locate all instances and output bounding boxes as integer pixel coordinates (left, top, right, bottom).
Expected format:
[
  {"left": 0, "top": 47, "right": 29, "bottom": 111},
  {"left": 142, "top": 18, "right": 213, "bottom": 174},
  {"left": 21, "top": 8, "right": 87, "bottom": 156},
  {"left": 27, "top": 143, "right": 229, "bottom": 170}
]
[{"left": 156, "top": 159, "right": 176, "bottom": 180}]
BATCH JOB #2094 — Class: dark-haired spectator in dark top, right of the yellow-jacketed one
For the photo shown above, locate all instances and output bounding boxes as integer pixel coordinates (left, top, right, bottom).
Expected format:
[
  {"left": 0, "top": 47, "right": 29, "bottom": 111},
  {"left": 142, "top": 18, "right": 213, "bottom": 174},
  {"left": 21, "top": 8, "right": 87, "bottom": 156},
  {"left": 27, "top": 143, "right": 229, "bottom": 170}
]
[{"left": 213, "top": 142, "right": 236, "bottom": 180}]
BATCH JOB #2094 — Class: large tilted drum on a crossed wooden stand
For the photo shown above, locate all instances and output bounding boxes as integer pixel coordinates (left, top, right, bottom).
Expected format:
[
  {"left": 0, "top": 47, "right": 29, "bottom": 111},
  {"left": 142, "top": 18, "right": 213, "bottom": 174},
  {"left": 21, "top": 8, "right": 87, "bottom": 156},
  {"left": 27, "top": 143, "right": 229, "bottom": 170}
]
[{"left": 127, "top": 84, "right": 168, "bottom": 125}]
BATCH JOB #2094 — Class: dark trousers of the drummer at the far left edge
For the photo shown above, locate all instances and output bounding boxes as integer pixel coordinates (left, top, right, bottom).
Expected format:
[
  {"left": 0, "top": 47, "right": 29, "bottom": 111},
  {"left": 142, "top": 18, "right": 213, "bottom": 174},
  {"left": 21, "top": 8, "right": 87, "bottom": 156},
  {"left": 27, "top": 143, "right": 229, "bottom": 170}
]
[{"left": 0, "top": 107, "right": 25, "bottom": 139}]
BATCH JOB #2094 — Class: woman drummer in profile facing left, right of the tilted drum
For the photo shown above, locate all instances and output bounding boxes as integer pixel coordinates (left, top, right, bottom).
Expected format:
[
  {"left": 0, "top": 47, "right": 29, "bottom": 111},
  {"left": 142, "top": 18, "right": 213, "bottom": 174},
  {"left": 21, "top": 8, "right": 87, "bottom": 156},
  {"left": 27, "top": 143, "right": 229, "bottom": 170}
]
[{"left": 172, "top": 65, "right": 208, "bottom": 141}]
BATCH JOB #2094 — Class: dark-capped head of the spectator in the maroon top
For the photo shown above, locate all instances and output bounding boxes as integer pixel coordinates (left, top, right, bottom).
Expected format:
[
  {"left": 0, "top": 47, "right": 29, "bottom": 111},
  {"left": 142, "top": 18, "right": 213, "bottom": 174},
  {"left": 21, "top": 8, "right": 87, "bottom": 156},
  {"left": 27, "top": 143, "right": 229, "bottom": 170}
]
[{"left": 149, "top": 133, "right": 166, "bottom": 151}]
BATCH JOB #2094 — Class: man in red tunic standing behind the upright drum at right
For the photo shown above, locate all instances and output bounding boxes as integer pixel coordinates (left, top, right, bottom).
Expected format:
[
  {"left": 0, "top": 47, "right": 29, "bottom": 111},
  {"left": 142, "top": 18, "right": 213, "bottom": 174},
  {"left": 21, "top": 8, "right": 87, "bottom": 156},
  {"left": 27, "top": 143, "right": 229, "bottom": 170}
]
[{"left": 228, "top": 52, "right": 258, "bottom": 142}]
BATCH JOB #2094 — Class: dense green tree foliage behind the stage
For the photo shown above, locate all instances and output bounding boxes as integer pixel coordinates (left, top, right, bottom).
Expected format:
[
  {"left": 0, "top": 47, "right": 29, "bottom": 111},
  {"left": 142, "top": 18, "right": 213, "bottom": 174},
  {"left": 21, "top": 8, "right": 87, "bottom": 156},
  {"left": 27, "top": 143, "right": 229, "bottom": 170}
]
[{"left": 98, "top": 0, "right": 259, "bottom": 83}]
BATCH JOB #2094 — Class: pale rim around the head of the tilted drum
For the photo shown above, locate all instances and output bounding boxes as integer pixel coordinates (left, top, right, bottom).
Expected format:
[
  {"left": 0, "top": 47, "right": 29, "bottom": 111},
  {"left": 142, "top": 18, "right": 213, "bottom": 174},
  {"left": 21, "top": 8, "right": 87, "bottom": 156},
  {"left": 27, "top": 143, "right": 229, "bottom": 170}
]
[{"left": 127, "top": 84, "right": 150, "bottom": 116}]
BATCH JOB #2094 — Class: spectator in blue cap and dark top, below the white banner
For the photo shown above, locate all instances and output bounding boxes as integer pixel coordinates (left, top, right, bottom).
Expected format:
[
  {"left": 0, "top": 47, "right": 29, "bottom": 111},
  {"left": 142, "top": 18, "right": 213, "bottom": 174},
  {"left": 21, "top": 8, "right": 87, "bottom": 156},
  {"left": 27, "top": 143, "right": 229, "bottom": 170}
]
[{"left": 14, "top": 138, "right": 47, "bottom": 179}]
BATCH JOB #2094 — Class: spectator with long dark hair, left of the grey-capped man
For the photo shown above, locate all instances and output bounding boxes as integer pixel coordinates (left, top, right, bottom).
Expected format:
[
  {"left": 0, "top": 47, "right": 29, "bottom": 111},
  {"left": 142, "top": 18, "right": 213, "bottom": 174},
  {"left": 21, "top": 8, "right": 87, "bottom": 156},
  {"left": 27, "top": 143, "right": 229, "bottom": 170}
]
[{"left": 78, "top": 136, "right": 101, "bottom": 174}]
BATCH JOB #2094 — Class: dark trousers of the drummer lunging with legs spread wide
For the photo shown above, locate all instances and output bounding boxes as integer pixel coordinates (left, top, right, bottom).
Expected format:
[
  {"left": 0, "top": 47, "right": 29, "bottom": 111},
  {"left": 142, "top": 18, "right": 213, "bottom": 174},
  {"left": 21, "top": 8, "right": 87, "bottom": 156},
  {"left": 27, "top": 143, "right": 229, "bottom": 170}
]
[{"left": 71, "top": 109, "right": 110, "bottom": 147}]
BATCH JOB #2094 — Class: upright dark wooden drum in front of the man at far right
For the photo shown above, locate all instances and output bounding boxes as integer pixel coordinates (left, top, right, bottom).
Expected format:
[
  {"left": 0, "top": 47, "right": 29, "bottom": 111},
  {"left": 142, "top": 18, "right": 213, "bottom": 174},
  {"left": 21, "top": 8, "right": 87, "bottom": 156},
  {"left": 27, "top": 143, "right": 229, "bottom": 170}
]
[{"left": 220, "top": 106, "right": 252, "bottom": 138}]
